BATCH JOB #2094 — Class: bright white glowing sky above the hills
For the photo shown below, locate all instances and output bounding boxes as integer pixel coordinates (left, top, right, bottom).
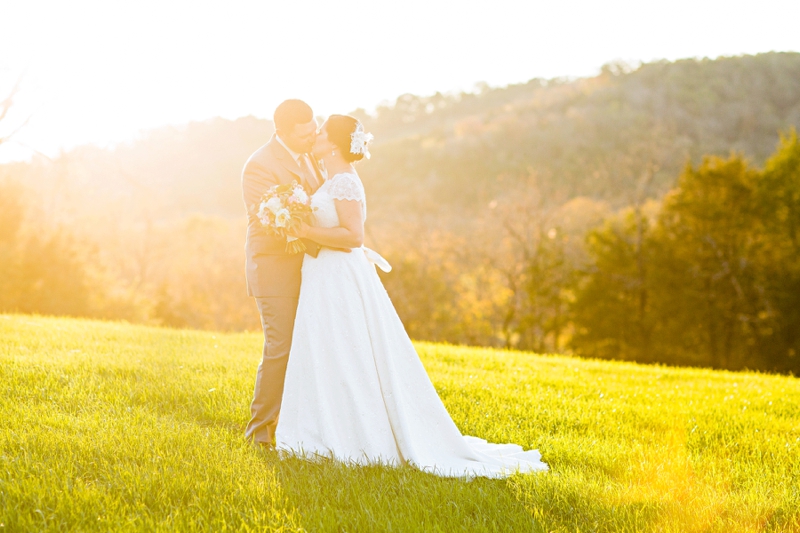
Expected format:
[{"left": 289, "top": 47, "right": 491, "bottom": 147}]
[{"left": 0, "top": 0, "right": 800, "bottom": 162}]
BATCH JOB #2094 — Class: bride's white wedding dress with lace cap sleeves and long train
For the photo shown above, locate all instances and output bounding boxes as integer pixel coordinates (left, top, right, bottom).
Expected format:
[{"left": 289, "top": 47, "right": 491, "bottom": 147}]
[{"left": 276, "top": 173, "right": 548, "bottom": 478}]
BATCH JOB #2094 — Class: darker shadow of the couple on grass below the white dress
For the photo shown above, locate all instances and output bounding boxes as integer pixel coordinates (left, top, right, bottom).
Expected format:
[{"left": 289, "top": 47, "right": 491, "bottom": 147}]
[{"left": 263, "top": 452, "right": 544, "bottom": 532}]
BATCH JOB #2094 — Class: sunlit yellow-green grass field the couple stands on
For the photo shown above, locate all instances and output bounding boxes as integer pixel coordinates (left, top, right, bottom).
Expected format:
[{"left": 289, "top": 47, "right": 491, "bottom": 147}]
[{"left": 0, "top": 315, "right": 800, "bottom": 532}]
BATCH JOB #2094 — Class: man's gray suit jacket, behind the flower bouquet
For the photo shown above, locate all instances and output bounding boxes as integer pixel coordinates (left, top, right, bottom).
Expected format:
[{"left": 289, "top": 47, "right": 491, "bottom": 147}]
[{"left": 242, "top": 135, "right": 322, "bottom": 298}]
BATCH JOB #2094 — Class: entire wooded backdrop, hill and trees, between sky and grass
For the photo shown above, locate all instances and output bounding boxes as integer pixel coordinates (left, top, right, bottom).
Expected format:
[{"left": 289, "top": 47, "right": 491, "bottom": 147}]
[{"left": 0, "top": 54, "right": 800, "bottom": 372}]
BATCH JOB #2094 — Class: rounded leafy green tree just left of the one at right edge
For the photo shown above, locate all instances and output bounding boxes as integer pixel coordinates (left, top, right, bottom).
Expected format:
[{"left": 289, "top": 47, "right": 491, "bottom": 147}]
[{"left": 654, "top": 155, "right": 765, "bottom": 369}]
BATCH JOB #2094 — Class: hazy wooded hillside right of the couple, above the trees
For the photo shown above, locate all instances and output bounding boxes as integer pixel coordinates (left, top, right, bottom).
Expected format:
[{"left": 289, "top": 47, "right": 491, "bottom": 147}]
[{"left": 365, "top": 53, "right": 800, "bottom": 212}]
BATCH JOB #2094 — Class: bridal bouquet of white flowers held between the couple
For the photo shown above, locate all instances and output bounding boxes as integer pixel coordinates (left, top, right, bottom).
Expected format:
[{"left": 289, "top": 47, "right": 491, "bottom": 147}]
[{"left": 257, "top": 181, "right": 312, "bottom": 254}]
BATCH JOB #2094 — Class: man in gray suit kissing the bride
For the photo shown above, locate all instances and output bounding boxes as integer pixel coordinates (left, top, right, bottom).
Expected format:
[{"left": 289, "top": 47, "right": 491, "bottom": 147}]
[{"left": 242, "top": 100, "right": 323, "bottom": 447}]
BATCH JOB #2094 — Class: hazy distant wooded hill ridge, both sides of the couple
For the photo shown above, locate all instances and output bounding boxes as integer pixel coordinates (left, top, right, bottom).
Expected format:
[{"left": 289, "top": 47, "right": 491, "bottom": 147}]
[{"left": 6, "top": 53, "right": 800, "bottom": 217}]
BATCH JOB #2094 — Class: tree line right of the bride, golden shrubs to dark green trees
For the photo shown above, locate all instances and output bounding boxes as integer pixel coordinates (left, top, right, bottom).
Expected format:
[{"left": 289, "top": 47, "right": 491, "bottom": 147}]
[{"left": 366, "top": 132, "right": 800, "bottom": 372}]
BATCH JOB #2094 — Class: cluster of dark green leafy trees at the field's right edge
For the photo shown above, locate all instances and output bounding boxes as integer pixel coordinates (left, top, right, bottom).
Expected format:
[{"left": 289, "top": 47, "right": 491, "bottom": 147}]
[{"left": 572, "top": 139, "right": 800, "bottom": 372}]
